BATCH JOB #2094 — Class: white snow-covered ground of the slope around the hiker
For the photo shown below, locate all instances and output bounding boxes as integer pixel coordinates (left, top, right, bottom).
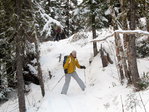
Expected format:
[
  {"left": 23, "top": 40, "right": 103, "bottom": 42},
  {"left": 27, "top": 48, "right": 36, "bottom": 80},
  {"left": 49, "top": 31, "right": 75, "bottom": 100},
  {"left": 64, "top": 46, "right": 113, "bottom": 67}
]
[{"left": 0, "top": 29, "right": 149, "bottom": 112}]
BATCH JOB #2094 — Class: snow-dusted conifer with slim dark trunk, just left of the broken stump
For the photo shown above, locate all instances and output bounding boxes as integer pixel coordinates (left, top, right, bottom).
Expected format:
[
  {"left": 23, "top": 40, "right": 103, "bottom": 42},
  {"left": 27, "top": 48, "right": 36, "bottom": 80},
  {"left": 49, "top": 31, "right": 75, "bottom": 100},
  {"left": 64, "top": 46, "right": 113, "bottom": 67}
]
[{"left": 81, "top": 0, "right": 108, "bottom": 56}]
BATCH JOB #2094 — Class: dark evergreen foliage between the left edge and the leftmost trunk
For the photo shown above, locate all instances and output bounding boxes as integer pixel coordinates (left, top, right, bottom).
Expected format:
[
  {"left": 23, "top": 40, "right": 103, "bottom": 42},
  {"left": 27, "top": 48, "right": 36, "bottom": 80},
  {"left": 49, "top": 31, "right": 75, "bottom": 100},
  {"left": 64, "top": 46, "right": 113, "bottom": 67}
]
[{"left": 0, "top": 0, "right": 16, "bottom": 91}]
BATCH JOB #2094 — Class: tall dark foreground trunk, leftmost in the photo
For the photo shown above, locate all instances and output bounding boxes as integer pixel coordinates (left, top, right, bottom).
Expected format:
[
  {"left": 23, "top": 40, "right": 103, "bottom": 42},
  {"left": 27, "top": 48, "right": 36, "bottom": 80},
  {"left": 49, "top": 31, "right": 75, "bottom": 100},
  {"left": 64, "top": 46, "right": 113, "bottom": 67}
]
[{"left": 16, "top": 0, "right": 26, "bottom": 112}]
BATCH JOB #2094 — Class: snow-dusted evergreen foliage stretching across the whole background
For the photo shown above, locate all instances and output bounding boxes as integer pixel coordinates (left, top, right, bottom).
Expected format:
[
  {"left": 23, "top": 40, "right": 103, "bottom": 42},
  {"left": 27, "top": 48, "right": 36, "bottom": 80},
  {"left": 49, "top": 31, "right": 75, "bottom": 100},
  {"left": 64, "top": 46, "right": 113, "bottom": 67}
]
[{"left": 0, "top": 0, "right": 149, "bottom": 103}]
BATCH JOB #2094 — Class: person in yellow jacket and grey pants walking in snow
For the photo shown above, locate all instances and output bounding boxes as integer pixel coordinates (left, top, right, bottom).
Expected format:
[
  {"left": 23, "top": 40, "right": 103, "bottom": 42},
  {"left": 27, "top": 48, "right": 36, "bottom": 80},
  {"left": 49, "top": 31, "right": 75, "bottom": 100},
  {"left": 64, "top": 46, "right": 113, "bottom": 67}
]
[{"left": 61, "top": 51, "right": 86, "bottom": 94}]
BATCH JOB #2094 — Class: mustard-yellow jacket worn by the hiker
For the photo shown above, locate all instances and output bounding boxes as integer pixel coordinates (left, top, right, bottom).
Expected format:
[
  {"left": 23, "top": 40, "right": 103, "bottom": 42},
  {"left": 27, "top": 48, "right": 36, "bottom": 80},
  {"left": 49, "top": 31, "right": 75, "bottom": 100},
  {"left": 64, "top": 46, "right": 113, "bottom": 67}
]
[{"left": 64, "top": 55, "right": 80, "bottom": 74}]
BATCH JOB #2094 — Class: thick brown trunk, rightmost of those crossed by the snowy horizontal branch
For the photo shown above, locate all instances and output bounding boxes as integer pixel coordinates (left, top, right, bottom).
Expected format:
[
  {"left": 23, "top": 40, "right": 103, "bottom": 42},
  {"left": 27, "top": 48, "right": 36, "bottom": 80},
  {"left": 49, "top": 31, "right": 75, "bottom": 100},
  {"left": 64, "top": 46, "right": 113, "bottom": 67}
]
[{"left": 128, "top": 0, "right": 140, "bottom": 89}]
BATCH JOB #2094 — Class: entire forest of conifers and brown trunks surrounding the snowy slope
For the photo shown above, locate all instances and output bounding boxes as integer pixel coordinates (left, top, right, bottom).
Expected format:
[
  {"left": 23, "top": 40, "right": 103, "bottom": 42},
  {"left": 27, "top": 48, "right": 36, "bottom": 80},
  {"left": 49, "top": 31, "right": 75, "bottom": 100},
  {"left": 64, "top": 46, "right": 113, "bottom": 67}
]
[{"left": 0, "top": 0, "right": 149, "bottom": 112}]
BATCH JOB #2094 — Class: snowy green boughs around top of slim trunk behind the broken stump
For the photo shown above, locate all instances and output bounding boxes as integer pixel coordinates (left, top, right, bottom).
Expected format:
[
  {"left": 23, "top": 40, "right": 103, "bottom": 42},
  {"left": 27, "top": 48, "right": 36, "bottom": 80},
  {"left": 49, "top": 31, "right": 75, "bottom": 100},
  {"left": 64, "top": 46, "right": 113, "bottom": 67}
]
[{"left": 76, "top": 0, "right": 109, "bottom": 29}]
